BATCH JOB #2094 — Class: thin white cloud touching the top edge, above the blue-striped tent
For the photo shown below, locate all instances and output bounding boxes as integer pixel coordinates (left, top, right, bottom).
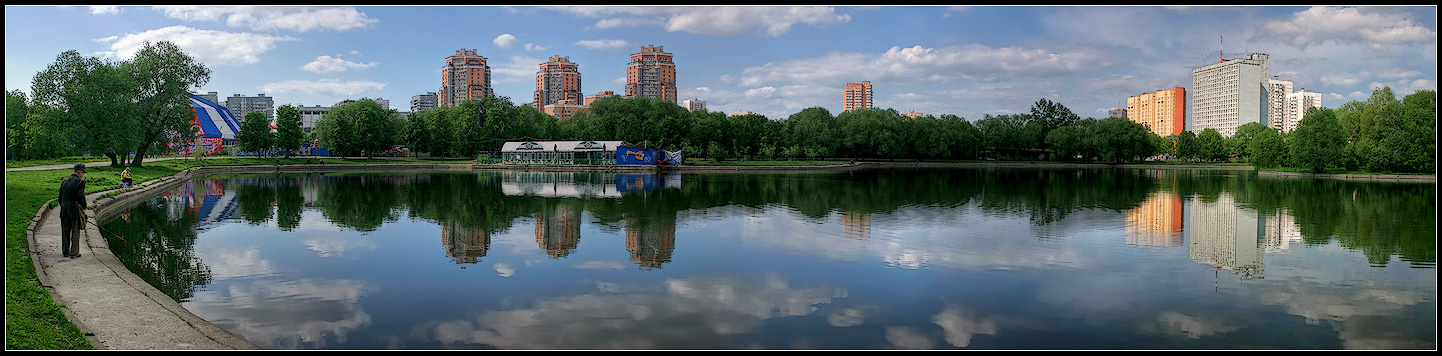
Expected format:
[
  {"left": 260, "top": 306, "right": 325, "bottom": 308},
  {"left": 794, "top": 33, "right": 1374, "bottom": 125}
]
[{"left": 153, "top": 6, "right": 378, "bottom": 32}]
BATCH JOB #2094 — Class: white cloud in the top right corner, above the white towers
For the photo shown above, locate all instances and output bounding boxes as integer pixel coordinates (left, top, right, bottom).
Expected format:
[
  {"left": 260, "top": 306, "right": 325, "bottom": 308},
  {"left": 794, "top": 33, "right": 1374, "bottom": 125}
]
[{"left": 1260, "top": 6, "right": 1438, "bottom": 49}]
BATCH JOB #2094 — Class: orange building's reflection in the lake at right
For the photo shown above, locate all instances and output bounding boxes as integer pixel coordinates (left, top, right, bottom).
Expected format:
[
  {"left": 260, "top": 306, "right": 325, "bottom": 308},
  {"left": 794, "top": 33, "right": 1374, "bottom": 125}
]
[{"left": 1126, "top": 190, "right": 1182, "bottom": 248}]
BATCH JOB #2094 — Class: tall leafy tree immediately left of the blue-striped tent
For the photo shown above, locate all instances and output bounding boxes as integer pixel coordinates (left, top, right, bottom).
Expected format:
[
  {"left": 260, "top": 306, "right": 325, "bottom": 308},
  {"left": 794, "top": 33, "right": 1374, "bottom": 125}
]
[{"left": 127, "top": 40, "right": 211, "bottom": 167}]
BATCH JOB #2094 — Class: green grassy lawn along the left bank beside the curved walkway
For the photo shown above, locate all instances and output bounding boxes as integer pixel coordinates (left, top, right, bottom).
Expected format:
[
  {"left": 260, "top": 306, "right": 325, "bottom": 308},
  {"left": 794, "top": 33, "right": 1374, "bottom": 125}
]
[{"left": 4, "top": 157, "right": 473, "bottom": 350}]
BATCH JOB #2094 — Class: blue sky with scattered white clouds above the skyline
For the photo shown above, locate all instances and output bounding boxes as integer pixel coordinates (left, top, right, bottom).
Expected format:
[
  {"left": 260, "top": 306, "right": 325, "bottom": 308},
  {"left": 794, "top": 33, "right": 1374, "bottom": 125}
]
[{"left": 4, "top": 6, "right": 1438, "bottom": 121}]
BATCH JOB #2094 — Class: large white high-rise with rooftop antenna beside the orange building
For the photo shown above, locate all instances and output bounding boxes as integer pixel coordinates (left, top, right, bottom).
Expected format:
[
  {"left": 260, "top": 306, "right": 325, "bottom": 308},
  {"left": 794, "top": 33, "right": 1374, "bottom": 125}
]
[{"left": 1191, "top": 53, "right": 1270, "bottom": 137}]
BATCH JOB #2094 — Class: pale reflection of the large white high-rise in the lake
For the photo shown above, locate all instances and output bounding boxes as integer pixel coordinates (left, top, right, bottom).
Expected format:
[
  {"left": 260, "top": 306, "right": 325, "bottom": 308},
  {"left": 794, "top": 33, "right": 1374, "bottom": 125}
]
[{"left": 1187, "top": 192, "right": 1266, "bottom": 278}]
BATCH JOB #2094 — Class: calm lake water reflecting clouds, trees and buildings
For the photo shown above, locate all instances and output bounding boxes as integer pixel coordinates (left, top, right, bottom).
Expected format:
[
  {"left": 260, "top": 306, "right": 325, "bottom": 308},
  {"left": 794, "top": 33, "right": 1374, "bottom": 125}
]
[{"left": 105, "top": 169, "right": 1438, "bottom": 350}]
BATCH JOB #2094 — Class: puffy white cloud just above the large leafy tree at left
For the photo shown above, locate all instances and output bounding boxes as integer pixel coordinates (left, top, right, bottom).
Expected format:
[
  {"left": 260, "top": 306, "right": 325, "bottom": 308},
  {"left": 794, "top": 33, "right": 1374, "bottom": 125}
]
[{"left": 97, "top": 26, "right": 296, "bottom": 65}]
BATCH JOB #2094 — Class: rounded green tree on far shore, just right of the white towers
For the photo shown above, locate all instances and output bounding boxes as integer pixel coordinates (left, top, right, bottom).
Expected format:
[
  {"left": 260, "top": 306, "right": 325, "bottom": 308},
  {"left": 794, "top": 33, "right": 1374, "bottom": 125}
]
[{"left": 1291, "top": 108, "right": 1347, "bottom": 173}]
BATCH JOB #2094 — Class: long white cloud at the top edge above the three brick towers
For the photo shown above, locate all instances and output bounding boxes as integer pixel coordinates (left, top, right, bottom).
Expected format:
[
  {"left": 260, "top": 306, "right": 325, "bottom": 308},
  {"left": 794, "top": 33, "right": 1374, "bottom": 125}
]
[{"left": 554, "top": 6, "right": 851, "bottom": 37}]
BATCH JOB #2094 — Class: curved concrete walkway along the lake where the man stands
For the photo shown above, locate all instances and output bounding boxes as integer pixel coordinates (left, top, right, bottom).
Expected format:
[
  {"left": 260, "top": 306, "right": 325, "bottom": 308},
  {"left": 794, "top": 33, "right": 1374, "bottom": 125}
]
[{"left": 27, "top": 174, "right": 260, "bottom": 350}]
